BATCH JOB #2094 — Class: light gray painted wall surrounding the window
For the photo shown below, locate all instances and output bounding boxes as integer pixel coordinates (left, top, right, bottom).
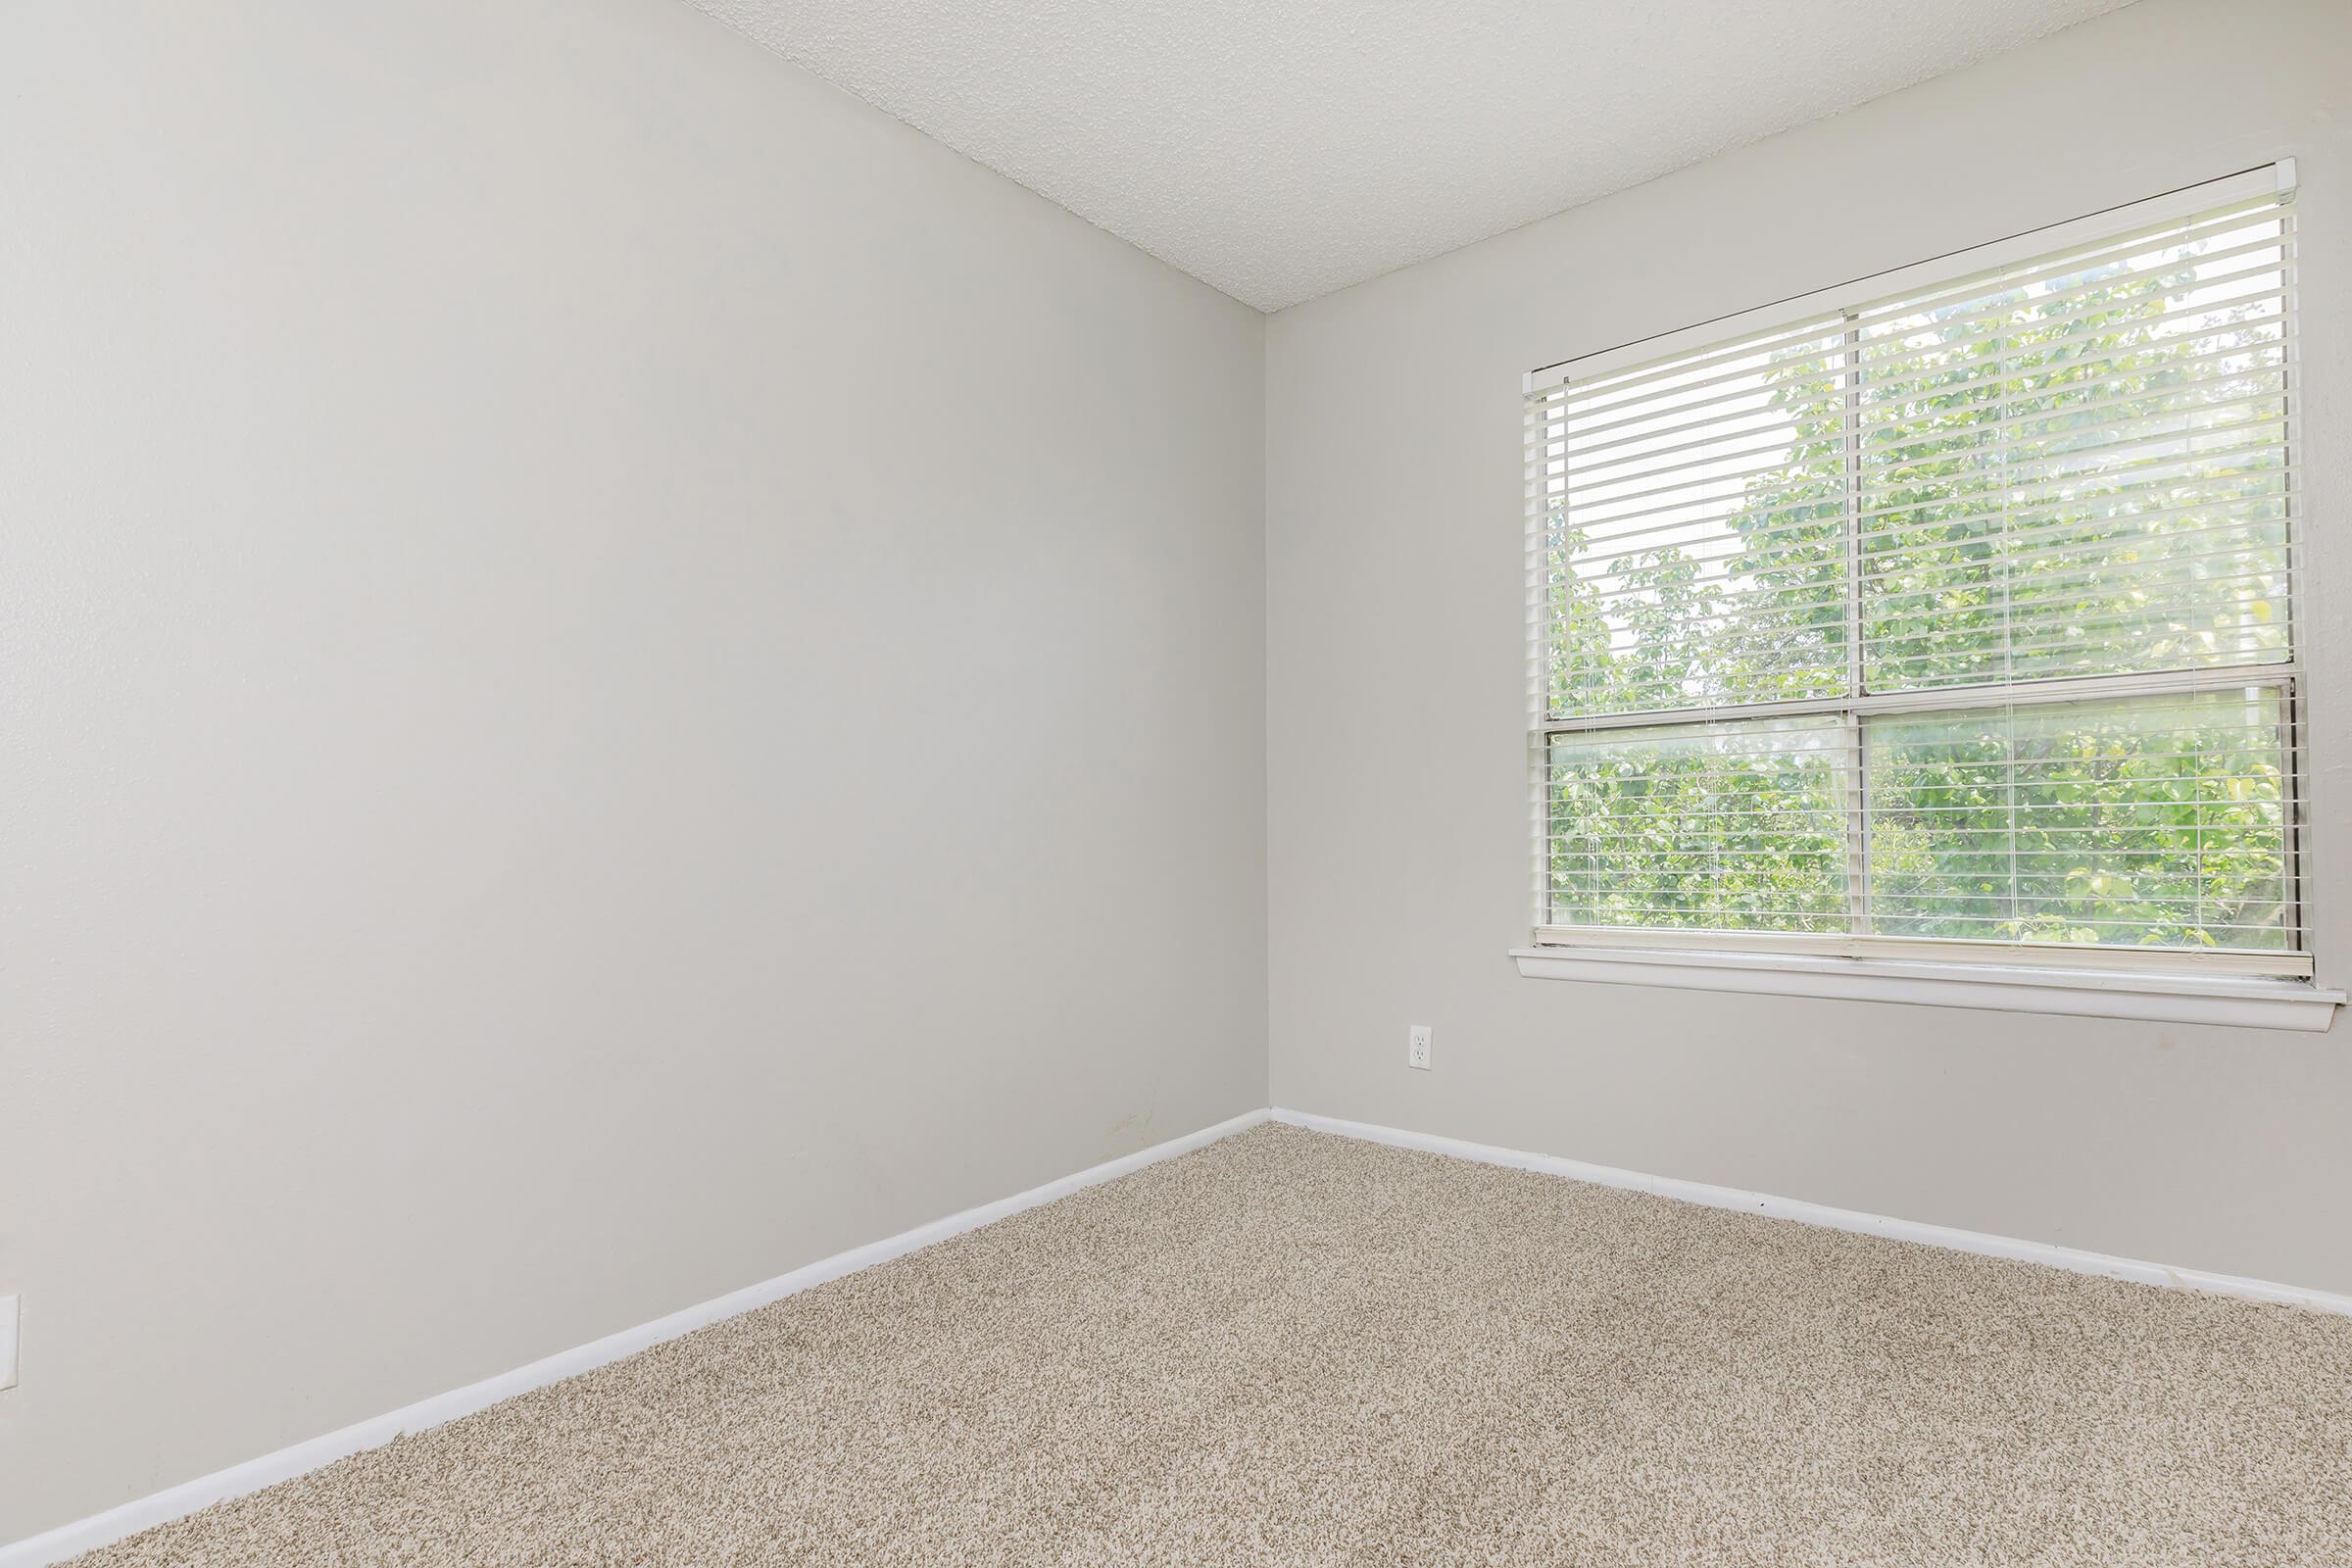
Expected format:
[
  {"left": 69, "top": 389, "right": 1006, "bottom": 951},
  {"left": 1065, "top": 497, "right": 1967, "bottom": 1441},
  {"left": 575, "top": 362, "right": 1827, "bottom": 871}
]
[{"left": 1268, "top": 0, "right": 2352, "bottom": 1291}]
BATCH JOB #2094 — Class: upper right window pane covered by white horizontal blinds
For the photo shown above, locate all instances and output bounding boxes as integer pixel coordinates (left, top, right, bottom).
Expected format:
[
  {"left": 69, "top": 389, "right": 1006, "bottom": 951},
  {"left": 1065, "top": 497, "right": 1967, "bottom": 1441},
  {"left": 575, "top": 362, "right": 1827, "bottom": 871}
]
[{"left": 1853, "top": 202, "right": 2293, "bottom": 691}]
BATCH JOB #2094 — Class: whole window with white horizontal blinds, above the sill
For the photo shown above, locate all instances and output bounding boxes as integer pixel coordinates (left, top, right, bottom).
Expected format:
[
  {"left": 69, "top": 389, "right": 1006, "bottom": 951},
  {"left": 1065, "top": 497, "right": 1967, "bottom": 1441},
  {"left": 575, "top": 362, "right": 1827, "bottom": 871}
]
[{"left": 1529, "top": 170, "right": 2310, "bottom": 976}]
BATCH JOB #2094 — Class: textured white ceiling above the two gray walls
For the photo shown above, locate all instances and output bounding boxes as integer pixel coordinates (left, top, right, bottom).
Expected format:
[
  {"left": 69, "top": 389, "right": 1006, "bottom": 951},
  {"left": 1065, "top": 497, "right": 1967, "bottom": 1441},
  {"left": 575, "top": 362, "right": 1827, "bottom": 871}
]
[{"left": 694, "top": 0, "right": 2129, "bottom": 311}]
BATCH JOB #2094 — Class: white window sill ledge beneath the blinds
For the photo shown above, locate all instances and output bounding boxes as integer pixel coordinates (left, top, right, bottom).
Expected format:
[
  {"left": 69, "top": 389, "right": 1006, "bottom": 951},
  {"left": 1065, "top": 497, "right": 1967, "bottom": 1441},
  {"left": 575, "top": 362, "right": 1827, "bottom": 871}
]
[{"left": 1510, "top": 948, "right": 2345, "bottom": 1030}]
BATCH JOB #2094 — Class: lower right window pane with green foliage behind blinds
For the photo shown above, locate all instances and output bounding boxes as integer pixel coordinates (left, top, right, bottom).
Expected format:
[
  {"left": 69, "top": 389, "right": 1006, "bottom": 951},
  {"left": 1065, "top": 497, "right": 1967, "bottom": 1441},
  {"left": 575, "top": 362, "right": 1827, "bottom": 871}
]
[{"left": 1863, "top": 686, "right": 2295, "bottom": 950}]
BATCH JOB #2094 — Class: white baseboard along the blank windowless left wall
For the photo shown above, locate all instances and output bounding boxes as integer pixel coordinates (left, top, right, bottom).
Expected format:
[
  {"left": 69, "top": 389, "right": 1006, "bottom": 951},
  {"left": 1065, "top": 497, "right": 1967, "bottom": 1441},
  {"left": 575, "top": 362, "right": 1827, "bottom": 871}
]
[{"left": 0, "top": 1109, "right": 1268, "bottom": 1568}]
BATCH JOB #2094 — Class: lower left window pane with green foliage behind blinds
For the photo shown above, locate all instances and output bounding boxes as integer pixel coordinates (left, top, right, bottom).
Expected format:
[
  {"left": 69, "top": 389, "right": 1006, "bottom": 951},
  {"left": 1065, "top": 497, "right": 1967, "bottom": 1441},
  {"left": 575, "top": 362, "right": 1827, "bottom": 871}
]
[{"left": 1547, "top": 719, "right": 1851, "bottom": 933}]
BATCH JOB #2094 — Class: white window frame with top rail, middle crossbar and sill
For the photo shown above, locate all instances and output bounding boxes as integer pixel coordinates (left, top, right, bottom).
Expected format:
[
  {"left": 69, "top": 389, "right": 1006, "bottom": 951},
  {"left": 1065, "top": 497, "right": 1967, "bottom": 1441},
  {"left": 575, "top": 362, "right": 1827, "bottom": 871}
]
[{"left": 1512, "top": 160, "right": 2345, "bottom": 1030}]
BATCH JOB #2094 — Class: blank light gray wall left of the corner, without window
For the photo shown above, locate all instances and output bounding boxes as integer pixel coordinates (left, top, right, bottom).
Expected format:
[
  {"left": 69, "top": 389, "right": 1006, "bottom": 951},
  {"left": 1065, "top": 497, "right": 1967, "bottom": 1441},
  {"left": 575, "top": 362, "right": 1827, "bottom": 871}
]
[{"left": 0, "top": 0, "right": 1265, "bottom": 1540}]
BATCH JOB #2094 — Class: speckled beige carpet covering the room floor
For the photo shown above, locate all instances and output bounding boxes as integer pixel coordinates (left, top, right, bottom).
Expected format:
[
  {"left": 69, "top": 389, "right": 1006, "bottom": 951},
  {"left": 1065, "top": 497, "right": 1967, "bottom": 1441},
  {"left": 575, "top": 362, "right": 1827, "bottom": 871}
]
[{"left": 69, "top": 1126, "right": 2352, "bottom": 1568}]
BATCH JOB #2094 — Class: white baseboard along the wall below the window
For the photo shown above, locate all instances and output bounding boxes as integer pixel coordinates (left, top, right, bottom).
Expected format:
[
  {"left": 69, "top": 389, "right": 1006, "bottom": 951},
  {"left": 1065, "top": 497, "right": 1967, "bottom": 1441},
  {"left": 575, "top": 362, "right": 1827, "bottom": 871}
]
[{"left": 1272, "top": 1104, "right": 2352, "bottom": 1316}]
